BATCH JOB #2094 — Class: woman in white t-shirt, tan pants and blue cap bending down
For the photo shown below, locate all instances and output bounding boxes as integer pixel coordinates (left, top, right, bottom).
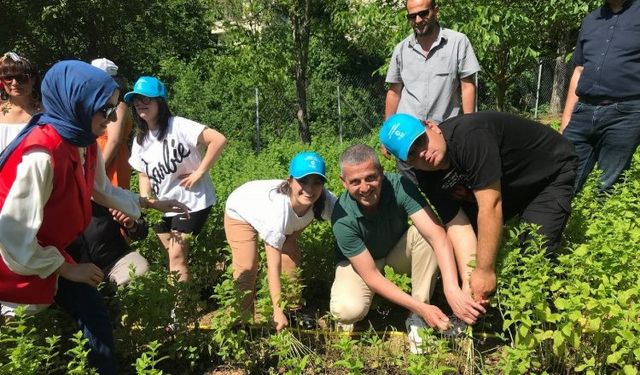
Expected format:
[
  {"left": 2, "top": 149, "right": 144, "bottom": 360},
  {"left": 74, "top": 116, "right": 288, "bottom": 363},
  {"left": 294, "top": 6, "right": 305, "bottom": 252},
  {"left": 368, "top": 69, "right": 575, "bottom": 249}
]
[{"left": 224, "top": 152, "right": 336, "bottom": 331}]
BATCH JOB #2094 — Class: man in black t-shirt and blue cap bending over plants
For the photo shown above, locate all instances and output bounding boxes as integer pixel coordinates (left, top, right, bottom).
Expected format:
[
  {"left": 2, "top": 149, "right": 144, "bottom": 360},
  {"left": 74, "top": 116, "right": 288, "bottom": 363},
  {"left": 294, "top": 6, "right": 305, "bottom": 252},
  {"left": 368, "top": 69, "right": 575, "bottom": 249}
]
[{"left": 380, "top": 112, "right": 577, "bottom": 301}]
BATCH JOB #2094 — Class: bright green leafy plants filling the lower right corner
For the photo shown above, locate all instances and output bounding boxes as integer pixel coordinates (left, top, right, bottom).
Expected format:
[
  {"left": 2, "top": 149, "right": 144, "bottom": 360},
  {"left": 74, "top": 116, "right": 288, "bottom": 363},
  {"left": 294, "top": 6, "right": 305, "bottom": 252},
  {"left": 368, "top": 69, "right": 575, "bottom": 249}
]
[{"left": 490, "top": 154, "right": 640, "bottom": 374}]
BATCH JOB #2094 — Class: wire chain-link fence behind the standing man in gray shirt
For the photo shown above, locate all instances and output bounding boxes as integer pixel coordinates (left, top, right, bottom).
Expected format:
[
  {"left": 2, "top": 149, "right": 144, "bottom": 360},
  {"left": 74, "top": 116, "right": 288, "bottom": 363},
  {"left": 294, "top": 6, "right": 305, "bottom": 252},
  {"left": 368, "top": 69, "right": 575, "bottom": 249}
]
[{"left": 251, "top": 59, "right": 573, "bottom": 152}]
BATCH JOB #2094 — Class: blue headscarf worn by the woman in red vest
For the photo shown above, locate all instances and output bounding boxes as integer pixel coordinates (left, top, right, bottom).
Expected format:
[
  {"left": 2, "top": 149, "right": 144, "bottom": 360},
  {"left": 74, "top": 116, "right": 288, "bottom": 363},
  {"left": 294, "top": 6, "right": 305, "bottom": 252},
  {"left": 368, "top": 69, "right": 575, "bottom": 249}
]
[{"left": 0, "top": 60, "right": 118, "bottom": 168}]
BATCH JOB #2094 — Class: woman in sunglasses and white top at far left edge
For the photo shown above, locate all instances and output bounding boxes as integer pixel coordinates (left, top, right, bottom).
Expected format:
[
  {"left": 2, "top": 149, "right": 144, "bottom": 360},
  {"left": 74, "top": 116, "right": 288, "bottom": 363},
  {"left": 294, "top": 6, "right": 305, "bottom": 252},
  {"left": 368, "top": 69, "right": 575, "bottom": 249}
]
[{"left": 0, "top": 52, "right": 40, "bottom": 151}]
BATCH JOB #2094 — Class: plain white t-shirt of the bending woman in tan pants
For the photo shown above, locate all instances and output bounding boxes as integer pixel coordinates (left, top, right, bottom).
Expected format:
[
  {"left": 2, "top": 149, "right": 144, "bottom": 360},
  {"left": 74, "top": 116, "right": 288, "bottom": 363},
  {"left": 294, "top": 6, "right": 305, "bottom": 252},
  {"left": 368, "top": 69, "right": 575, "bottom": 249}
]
[{"left": 225, "top": 180, "right": 336, "bottom": 249}]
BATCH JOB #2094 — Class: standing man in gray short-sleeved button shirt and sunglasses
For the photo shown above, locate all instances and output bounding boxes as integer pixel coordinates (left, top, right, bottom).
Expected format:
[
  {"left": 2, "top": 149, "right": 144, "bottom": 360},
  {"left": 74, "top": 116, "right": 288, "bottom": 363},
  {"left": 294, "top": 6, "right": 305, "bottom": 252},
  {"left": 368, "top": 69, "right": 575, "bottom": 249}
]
[{"left": 385, "top": 0, "right": 480, "bottom": 122}]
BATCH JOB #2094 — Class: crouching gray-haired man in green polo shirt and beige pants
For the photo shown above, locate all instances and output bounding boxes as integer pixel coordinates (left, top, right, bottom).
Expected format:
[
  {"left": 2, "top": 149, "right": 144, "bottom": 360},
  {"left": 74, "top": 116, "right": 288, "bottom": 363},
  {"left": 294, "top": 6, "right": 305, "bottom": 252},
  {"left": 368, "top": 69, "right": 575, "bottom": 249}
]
[{"left": 330, "top": 145, "right": 485, "bottom": 352}]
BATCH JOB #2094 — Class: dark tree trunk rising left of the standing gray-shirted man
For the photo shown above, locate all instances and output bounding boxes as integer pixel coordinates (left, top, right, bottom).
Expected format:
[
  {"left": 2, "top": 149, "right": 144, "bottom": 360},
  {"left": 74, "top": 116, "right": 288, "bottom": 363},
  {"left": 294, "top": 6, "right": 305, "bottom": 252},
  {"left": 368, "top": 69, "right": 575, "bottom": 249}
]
[{"left": 290, "top": 0, "right": 311, "bottom": 144}]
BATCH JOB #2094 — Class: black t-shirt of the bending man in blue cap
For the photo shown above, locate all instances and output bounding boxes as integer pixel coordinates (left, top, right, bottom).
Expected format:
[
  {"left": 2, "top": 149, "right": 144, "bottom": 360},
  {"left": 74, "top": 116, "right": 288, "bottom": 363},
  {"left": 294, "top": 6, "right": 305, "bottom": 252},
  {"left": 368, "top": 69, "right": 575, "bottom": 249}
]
[{"left": 416, "top": 112, "right": 576, "bottom": 223}]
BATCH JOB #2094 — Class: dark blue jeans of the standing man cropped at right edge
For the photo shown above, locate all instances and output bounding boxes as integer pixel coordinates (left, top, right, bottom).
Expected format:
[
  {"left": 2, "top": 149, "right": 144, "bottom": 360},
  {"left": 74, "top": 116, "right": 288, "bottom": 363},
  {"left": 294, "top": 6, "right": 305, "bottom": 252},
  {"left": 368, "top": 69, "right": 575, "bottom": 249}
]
[{"left": 564, "top": 100, "right": 640, "bottom": 192}]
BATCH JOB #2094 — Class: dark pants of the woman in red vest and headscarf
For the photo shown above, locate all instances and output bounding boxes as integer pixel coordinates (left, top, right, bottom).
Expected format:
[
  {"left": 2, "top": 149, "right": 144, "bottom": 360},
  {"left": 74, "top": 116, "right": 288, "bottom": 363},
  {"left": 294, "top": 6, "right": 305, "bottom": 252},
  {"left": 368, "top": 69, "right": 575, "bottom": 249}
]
[{"left": 55, "top": 277, "right": 118, "bottom": 375}]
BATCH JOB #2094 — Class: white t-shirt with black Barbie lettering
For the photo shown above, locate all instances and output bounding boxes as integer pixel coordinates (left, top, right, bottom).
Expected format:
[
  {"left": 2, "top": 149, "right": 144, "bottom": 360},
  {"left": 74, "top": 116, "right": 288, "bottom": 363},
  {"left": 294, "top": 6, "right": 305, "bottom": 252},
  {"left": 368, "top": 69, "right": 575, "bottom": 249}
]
[{"left": 129, "top": 116, "right": 216, "bottom": 216}]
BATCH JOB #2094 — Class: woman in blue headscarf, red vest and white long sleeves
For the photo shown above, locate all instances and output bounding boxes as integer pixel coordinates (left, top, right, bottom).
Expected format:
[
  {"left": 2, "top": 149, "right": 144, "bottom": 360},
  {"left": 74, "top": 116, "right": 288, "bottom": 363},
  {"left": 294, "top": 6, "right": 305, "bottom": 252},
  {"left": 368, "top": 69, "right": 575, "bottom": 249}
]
[{"left": 0, "top": 61, "right": 186, "bottom": 374}]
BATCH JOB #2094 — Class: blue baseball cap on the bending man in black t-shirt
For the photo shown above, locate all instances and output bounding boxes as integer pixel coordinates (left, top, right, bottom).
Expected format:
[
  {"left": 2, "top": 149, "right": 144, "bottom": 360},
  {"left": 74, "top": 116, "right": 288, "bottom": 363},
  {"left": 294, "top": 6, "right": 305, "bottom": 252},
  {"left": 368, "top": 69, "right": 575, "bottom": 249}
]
[{"left": 380, "top": 113, "right": 426, "bottom": 161}]
